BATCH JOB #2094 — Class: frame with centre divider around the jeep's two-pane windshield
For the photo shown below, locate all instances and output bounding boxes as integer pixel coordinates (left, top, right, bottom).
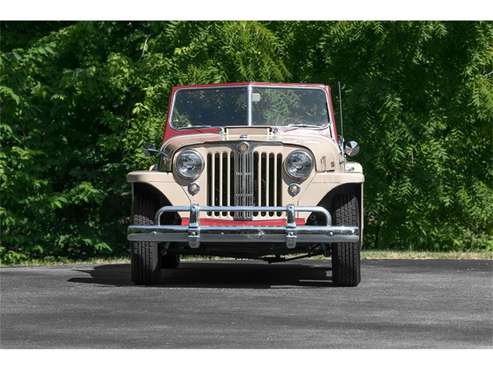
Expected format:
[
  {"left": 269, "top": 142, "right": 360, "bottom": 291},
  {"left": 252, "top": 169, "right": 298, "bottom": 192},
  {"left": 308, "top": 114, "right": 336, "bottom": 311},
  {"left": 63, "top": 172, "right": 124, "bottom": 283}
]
[{"left": 168, "top": 82, "right": 333, "bottom": 134}]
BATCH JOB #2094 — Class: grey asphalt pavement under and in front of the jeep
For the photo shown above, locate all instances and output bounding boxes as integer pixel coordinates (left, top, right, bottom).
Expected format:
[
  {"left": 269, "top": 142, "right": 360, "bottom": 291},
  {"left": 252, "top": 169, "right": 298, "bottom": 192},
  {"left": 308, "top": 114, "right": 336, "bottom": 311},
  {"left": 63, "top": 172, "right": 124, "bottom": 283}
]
[{"left": 0, "top": 260, "right": 493, "bottom": 348}]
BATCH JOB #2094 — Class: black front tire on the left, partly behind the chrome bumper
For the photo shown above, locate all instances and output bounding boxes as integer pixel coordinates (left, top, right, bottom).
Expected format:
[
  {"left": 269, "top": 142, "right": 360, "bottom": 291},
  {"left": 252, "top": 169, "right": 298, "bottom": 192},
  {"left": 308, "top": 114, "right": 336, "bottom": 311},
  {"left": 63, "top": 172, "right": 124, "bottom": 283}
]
[{"left": 130, "top": 195, "right": 160, "bottom": 285}]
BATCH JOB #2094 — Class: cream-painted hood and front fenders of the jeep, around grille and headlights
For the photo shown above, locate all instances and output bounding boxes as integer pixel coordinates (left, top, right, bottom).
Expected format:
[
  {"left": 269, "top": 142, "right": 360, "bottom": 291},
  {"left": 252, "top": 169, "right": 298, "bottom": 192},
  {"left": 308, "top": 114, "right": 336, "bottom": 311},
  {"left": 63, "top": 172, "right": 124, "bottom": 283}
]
[{"left": 127, "top": 126, "right": 364, "bottom": 231}]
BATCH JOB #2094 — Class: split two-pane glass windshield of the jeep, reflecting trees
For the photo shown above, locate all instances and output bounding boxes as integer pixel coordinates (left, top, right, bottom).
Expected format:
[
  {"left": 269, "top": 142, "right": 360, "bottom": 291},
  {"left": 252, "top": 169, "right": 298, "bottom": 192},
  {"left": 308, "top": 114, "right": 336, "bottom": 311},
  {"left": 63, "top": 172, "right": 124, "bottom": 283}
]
[{"left": 171, "top": 86, "right": 329, "bottom": 128}]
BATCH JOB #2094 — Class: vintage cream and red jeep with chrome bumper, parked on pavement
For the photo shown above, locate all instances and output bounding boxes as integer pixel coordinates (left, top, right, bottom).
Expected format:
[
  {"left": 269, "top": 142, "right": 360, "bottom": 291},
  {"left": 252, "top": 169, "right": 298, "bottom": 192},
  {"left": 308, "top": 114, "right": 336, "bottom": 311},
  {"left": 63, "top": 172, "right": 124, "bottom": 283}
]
[{"left": 128, "top": 82, "right": 364, "bottom": 286}]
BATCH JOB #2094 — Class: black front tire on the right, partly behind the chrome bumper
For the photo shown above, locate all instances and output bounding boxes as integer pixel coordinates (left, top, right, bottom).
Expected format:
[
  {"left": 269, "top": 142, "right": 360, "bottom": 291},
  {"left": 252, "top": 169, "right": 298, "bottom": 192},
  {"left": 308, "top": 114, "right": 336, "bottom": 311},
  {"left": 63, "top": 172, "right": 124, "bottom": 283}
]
[{"left": 331, "top": 194, "right": 361, "bottom": 286}]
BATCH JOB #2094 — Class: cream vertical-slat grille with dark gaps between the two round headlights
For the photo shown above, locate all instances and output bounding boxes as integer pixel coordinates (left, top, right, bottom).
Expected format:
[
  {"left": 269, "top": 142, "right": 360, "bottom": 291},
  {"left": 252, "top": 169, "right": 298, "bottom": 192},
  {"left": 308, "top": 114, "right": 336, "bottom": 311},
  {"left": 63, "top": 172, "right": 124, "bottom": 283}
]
[{"left": 207, "top": 150, "right": 282, "bottom": 220}]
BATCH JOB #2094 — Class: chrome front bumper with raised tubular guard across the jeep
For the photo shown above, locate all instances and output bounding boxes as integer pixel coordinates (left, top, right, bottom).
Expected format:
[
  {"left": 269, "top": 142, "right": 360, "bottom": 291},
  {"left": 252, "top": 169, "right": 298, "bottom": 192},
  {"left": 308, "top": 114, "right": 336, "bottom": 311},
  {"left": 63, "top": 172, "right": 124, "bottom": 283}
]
[{"left": 127, "top": 204, "right": 359, "bottom": 248}]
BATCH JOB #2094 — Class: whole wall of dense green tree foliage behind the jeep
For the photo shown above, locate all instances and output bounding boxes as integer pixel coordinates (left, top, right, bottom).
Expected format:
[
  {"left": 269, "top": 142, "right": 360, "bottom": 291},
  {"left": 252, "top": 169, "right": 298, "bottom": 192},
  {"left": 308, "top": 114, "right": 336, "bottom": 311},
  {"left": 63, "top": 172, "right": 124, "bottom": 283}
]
[{"left": 0, "top": 22, "right": 493, "bottom": 262}]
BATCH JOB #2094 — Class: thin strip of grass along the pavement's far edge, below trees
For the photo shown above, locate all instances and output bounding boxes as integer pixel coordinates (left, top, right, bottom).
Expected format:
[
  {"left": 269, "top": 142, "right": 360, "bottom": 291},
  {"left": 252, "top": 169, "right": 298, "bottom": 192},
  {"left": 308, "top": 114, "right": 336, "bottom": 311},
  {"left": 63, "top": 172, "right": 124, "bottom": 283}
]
[{"left": 0, "top": 250, "right": 493, "bottom": 267}]
